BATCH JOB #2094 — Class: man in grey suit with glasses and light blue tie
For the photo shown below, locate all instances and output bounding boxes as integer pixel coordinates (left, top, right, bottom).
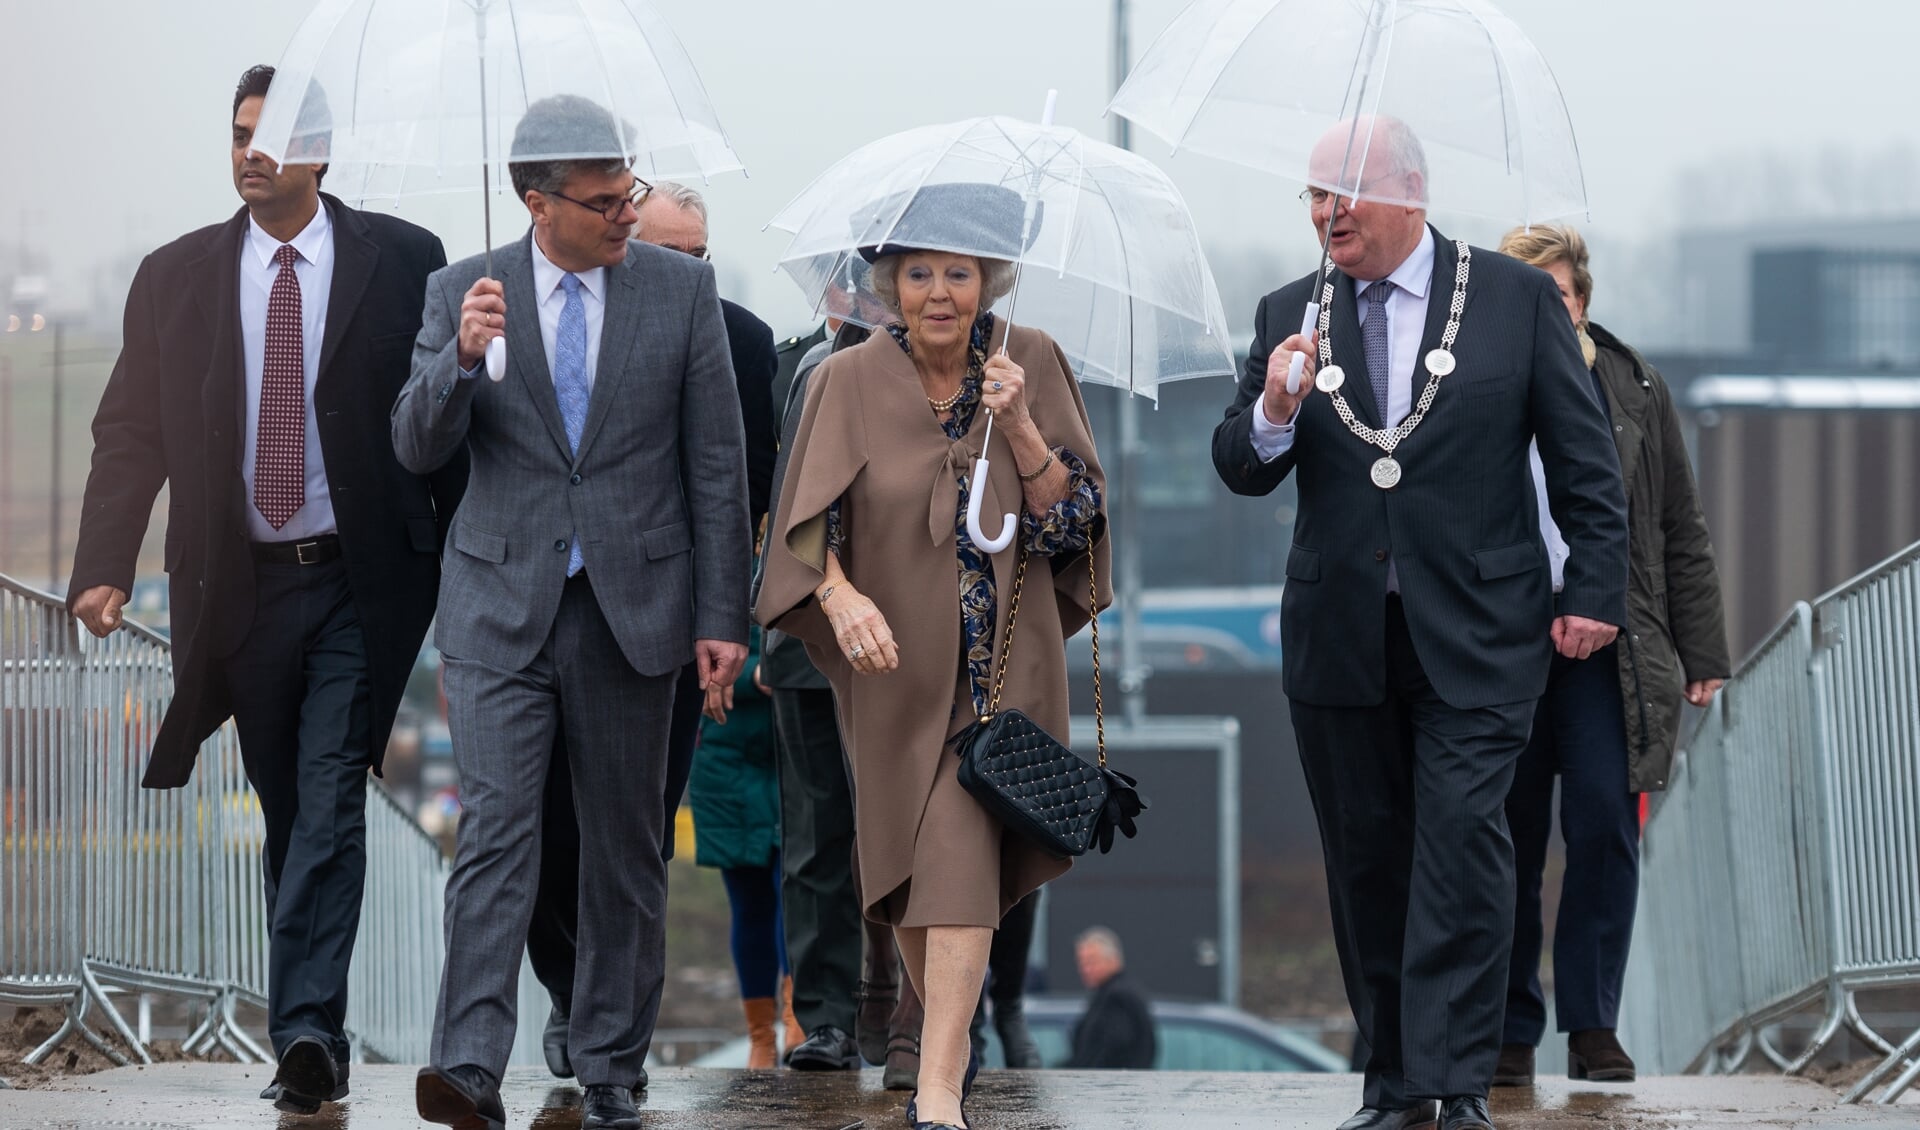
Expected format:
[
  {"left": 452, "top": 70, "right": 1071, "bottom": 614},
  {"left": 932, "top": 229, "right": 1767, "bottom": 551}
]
[{"left": 394, "top": 96, "right": 751, "bottom": 1130}]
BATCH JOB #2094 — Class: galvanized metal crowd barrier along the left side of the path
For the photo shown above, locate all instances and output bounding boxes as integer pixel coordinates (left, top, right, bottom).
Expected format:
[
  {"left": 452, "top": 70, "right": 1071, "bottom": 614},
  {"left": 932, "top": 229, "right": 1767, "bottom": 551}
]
[{"left": 0, "top": 576, "right": 545, "bottom": 1063}]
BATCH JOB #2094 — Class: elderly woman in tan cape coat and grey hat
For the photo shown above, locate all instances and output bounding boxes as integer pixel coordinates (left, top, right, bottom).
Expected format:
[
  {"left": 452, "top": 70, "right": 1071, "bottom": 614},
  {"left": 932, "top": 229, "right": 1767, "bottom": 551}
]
[{"left": 756, "top": 186, "right": 1110, "bottom": 1128}]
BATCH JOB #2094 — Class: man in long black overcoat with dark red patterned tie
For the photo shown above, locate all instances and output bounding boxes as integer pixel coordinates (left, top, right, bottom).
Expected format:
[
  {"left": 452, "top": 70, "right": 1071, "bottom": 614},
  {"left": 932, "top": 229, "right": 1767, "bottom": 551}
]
[{"left": 67, "top": 67, "right": 467, "bottom": 1115}]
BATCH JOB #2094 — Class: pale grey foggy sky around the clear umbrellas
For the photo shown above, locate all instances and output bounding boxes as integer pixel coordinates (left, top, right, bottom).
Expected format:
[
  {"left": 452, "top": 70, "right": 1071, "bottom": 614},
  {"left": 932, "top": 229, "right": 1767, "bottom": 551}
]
[{"left": 0, "top": 0, "right": 1920, "bottom": 343}]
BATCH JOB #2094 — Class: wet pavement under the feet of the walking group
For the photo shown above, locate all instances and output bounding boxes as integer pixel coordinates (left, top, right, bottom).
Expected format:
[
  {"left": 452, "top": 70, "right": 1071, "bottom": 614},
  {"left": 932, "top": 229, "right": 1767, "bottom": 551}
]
[{"left": 0, "top": 1063, "right": 1920, "bottom": 1130}]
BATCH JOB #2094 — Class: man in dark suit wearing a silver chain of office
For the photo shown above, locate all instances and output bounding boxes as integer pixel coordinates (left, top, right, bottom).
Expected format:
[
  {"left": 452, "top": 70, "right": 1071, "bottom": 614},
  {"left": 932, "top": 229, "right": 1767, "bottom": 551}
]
[{"left": 1213, "top": 117, "right": 1626, "bottom": 1130}]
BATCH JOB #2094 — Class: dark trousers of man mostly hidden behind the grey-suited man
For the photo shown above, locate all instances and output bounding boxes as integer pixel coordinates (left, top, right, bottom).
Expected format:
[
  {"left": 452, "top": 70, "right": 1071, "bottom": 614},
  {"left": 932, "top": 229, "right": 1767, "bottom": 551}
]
[{"left": 526, "top": 664, "right": 707, "bottom": 1013}]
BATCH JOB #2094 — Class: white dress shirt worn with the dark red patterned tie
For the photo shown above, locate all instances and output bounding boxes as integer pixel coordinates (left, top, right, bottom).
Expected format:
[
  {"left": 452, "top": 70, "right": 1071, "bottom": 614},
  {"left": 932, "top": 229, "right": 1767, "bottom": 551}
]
[{"left": 240, "top": 203, "right": 334, "bottom": 541}]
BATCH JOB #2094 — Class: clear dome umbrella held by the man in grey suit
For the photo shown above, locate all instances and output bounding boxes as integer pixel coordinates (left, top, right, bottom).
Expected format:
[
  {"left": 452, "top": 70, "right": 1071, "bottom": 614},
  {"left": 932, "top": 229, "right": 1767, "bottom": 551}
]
[{"left": 253, "top": 0, "right": 741, "bottom": 380}]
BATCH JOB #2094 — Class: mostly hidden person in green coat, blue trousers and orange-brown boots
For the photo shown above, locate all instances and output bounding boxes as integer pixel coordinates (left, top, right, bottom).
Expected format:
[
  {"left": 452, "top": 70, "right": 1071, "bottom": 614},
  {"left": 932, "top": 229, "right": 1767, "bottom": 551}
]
[{"left": 687, "top": 627, "right": 804, "bottom": 1067}]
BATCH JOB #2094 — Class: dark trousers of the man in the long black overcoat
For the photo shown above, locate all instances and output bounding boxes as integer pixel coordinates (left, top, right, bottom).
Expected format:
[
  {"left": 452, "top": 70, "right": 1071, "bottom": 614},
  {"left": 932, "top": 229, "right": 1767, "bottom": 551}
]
[{"left": 225, "top": 560, "right": 372, "bottom": 1061}]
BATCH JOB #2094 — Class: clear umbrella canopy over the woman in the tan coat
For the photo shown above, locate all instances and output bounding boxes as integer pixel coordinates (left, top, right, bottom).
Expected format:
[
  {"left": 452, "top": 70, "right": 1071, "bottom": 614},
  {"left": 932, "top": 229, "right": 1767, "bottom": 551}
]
[{"left": 770, "top": 117, "right": 1233, "bottom": 397}]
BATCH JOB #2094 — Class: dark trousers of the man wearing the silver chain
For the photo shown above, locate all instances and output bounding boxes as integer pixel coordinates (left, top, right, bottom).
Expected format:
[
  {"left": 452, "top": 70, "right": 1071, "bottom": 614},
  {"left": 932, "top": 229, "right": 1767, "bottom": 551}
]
[{"left": 1292, "top": 597, "right": 1534, "bottom": 1109}]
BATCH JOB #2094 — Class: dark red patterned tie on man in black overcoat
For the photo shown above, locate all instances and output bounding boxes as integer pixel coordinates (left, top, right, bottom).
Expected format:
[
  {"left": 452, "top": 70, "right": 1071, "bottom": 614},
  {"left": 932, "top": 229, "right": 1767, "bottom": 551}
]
[{"left": 253, "top": 244, "right": 307, "bottom": 530}]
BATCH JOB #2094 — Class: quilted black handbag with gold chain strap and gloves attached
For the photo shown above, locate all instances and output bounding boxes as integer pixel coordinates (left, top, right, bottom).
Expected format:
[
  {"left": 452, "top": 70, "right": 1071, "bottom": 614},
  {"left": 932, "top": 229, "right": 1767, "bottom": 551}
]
[{"left": 952, "top": 547, "right": 1146, "bottom": 856}]
